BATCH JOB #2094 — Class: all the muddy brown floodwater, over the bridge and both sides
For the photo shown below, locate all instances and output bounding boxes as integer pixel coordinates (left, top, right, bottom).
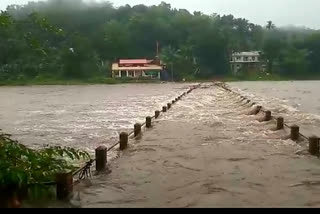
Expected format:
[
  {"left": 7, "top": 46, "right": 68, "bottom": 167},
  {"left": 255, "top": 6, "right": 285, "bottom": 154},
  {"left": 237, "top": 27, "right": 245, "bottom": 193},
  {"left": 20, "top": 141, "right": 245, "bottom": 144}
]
[{"left": 0, "top": 81, "right": 320, "bottom": 207}]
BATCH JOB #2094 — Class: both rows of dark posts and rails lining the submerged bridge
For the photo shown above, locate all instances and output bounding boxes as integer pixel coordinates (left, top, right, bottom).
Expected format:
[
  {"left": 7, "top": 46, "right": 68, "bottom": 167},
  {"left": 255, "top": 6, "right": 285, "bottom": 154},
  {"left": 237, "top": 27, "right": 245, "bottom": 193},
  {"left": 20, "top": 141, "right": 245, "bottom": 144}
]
[{"left": 23, "top": 82, "right": 320, "bottom": 200}]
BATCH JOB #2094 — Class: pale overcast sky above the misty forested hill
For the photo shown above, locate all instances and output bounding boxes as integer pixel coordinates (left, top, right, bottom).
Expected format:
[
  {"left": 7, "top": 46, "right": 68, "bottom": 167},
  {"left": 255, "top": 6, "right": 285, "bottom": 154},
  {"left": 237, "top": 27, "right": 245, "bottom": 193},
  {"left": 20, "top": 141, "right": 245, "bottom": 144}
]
[{"left": 0, "top": 0, "right": 320, "bottom": 29}]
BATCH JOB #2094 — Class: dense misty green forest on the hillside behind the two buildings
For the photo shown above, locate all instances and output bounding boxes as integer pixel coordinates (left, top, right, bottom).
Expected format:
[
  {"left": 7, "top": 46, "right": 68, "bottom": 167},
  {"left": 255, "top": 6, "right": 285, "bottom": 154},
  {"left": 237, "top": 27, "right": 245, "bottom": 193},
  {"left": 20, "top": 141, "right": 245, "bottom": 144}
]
[{"left": 0, "top": 0, "right": 320, "bottom": 84}]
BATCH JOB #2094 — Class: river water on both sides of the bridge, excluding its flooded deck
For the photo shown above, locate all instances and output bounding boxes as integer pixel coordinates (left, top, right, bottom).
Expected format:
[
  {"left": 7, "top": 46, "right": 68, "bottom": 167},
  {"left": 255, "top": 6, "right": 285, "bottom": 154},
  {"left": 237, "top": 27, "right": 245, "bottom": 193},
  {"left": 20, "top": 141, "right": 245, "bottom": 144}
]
[{"left": 0, "top": 81, "right": 320, "bottom": 151}]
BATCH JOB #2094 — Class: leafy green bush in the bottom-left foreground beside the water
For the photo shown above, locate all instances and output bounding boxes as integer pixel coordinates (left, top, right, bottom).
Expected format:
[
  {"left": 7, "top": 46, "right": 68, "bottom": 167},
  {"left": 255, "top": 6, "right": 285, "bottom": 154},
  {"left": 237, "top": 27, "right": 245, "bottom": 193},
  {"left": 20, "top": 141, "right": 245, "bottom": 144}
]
[{"left": 0, "top": 130, "right": 90, "bottom": 207}]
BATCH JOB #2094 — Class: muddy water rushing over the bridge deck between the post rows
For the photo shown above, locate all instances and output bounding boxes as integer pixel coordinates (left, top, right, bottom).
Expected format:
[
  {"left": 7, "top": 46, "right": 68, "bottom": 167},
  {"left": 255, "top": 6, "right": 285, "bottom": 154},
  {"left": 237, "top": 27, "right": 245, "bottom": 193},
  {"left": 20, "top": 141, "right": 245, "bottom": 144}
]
[{"left": 71, "top": 83, "right": 320, "bottom": 207}]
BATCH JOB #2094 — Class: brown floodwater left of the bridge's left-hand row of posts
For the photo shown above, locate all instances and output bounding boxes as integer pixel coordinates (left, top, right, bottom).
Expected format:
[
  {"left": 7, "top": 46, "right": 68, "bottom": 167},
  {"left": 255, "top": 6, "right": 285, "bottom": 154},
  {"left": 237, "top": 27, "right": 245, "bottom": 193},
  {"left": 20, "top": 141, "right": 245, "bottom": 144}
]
[{"left": 0, "top": 84, "right": 190, "bottom": 155}]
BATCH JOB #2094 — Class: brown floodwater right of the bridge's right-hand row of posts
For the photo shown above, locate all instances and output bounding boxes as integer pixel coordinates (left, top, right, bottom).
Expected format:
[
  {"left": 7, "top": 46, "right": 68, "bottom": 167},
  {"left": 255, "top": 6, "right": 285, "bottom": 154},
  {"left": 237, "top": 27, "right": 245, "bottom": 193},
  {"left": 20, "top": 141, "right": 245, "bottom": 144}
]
[{"left": 229, "top": 81, "right": 320, "bottom": 136}]
